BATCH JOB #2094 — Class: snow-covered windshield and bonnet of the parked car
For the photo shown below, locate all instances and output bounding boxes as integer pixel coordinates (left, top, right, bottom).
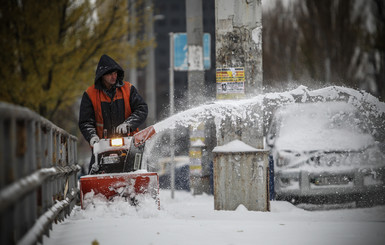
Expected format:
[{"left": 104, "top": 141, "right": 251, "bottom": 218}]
[{"left": 275, "top": 102, "right": 374, "bottom": 152}]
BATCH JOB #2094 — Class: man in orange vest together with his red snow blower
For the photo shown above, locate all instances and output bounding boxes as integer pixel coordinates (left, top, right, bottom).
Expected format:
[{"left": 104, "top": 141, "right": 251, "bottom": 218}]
[{"left": 79, "top": 55, "right": 158, "bottom": 209}]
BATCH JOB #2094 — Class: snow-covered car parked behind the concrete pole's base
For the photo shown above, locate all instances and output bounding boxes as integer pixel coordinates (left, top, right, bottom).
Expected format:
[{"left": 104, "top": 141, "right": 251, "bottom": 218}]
[{"left": 267, "top": 102, "right": 385, "bottom": 204}]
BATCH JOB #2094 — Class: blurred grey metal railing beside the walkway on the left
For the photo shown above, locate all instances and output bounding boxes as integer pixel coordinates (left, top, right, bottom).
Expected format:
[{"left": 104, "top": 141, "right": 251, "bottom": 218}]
[{"left": 0, "top": 102, "right": 80, "bottom": 244}]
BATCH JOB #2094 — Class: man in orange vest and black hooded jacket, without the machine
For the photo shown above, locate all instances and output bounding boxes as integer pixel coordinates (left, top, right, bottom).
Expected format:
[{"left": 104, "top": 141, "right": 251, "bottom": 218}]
[{"left": 79, "top": 55, "right": 148, "bottom": 172}]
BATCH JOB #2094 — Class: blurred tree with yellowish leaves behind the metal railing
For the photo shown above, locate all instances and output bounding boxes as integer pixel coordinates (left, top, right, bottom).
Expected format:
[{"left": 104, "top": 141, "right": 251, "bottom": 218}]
[{"left": 0, "top": 0, "right": 152, "bottom": 124}]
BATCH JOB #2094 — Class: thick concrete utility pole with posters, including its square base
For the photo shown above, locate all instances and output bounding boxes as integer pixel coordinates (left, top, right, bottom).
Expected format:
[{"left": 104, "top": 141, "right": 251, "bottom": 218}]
[{"left": 213, "top": 0, "right": 270, "bottom": 211}]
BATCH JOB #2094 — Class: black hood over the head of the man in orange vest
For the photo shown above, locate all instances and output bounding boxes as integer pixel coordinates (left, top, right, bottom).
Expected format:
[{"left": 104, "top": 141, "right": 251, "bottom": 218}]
[{"left": 95, "top": 54, "right": 124, "bottom": 89}]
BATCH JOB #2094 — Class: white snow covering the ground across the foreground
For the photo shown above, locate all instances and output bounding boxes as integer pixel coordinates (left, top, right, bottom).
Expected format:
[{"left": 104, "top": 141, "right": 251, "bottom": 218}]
[{"left": 43, "top": 190, "right": 385, "bottom": 245}]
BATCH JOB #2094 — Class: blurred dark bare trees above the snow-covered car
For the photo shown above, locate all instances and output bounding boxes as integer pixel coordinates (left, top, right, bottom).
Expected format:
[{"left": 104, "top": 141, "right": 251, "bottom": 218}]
[{"left": 263, "top": 0, "right": 385, "bottom": 98}]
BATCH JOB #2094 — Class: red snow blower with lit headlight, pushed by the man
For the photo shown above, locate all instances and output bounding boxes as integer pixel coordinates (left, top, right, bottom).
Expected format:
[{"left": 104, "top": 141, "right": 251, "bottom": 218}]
[{"left": 80, "top": 126, "right": 159, "bottom": 209}]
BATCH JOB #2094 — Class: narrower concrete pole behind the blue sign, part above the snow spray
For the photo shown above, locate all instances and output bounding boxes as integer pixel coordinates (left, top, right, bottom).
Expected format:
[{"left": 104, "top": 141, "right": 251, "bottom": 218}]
[{"left": 186, "top": 0, "right": 205, "bottom": 107}]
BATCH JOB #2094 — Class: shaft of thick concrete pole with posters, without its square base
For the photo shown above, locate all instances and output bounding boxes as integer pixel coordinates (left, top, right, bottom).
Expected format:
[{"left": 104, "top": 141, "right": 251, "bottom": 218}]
[{"left": 215, "top": 0, "right": 263, "bottom": 149}]
